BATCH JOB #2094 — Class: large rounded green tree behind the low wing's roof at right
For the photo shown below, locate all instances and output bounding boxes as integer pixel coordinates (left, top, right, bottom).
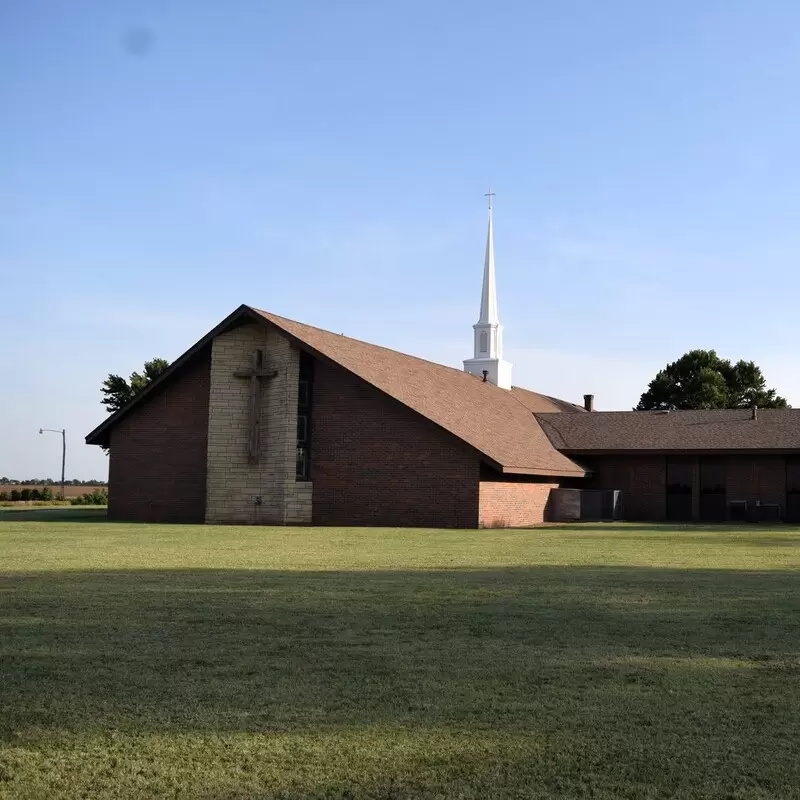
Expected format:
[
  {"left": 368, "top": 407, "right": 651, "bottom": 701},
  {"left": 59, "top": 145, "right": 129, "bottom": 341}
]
[{"left": 636, "top": 350, "right": 788, "bottom": 411}]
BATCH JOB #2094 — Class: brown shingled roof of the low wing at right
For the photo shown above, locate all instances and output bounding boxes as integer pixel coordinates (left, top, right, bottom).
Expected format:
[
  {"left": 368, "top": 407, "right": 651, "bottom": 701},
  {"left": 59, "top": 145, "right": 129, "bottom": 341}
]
[{"left": 536, "top": 409, "right": 800, "bottom": 453}]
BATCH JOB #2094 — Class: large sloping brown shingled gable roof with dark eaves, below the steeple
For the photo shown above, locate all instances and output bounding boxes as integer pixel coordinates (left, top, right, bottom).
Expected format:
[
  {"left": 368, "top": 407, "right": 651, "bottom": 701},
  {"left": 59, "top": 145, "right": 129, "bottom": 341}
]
[{"left": 86, "top": 306, "right": 587, "bottom": 477}]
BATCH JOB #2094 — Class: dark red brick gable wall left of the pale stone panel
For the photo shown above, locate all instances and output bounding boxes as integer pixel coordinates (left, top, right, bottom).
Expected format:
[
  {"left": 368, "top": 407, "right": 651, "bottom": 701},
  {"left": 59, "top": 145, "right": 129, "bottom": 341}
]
[{"left": 108, "top": 351, "right": 210, "bottom": 522}]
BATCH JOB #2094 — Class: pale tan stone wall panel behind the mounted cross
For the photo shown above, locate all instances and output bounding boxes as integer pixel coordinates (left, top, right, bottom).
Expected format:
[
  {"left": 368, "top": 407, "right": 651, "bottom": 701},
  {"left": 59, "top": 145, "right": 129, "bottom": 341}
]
[{"left": 206, "top": 325, "right": 312, "bottom": 525}]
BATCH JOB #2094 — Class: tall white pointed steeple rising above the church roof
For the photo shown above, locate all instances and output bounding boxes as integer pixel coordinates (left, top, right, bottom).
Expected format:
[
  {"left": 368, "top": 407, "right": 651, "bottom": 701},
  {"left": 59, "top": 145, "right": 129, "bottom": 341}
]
[{"left": 464, "top": 189, "right": 511, "bottom": 389}]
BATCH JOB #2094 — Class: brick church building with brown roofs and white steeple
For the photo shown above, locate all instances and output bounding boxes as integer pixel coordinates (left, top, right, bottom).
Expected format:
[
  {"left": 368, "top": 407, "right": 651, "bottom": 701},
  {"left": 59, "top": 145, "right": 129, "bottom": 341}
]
[{"left": 86, "top": 206, "right": 800, "bottom": 528}]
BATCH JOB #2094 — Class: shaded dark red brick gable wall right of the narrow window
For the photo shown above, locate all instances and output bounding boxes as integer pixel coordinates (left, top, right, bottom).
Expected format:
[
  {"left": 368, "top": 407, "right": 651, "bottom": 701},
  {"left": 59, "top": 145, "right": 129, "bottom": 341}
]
[{"left": 310, "top": 360, "right": 479, "bottom": 528}]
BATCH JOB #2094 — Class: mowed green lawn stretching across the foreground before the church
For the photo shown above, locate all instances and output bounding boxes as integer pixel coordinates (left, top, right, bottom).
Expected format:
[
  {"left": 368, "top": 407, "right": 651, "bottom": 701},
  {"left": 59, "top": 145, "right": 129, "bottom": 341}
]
[{"left": 0, "top": 509, "right": 800, "bottom": 799}]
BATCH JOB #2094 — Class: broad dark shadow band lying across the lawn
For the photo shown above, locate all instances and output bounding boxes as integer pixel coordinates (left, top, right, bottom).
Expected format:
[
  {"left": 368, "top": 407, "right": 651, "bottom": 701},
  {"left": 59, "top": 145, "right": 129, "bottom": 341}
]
[{"left": 0, "top": 567, "right": 800, "bottom": 739}]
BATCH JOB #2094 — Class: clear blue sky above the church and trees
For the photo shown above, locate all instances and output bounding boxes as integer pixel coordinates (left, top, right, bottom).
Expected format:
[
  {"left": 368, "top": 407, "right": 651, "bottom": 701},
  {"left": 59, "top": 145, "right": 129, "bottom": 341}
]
[{"left": 0, "top": 0, "right": 800, "bottom": 478}]
